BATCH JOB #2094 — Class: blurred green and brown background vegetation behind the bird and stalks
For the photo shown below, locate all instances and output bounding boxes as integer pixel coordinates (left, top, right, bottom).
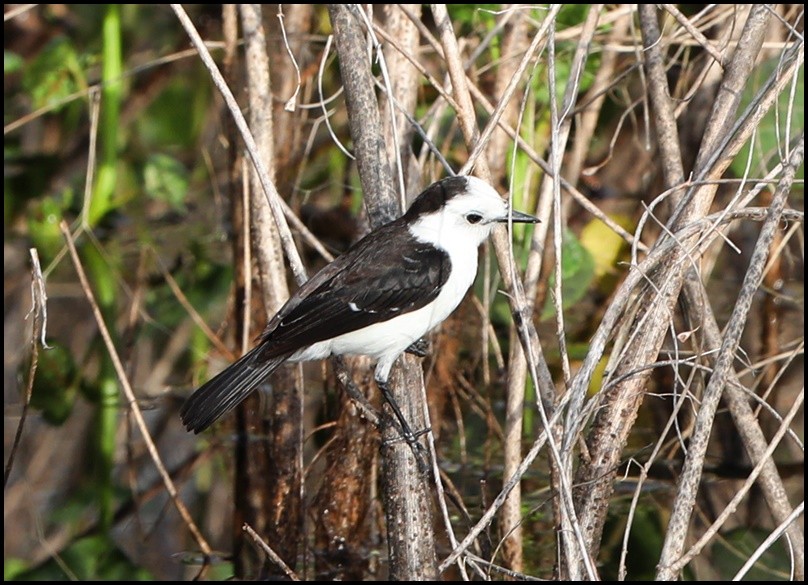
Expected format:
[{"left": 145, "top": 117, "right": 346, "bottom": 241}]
[{"left": 4, "top": 4, "right": 804, "bottom": 580}]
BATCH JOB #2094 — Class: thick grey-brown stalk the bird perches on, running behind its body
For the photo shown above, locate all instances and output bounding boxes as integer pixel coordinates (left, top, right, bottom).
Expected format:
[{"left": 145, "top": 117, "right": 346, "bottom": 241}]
[{"left": 328, "top": 4, "right": 437, "bottom": 581}]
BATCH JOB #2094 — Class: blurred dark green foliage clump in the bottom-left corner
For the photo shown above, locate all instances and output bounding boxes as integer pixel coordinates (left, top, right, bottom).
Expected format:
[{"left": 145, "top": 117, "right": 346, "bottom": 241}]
[{"left": 4, "top": 535, "right": 154, "bottom": 581}]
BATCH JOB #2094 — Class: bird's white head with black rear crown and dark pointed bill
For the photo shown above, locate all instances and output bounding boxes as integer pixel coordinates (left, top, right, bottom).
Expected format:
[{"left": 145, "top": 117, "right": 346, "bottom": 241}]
[{"left": 404, "top": 176, "right": 539, "bottom": 249}]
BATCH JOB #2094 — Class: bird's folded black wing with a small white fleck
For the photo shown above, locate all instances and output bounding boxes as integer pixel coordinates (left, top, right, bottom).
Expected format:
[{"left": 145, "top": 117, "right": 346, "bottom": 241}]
[{"left": 261, "top": 220, "right": 451, "bottom": 359}]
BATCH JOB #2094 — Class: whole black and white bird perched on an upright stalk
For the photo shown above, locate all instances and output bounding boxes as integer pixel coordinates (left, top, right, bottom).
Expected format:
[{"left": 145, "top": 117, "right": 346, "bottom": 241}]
[{"left": 180, "top": 176, "right": 538, "bottom": 441}]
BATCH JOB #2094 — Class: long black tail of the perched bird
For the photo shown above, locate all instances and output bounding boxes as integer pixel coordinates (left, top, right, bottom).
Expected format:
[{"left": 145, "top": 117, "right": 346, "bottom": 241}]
[{"left": 180, "top": 345, "right": 289, "bottom": 433}]
